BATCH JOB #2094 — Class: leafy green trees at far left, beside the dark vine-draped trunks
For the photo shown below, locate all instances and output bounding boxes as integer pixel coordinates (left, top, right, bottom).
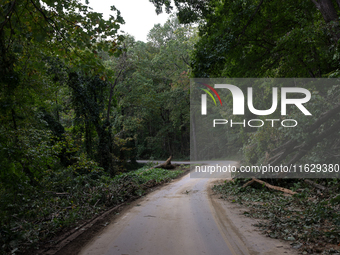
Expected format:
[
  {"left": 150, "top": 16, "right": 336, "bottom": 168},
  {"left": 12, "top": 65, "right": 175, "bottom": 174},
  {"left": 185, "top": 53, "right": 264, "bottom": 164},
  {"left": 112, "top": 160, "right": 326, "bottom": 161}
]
[{"left": 0, "top": 0, "right": 124, "bottom": 182}]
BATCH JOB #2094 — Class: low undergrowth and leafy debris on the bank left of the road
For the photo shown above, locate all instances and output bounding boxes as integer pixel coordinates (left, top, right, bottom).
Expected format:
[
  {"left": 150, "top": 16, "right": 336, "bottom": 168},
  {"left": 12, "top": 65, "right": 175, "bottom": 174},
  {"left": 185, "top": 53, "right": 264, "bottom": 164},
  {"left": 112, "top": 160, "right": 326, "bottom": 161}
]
[{"left": 0, "top": 159, "right": 183, "bottom": 254}]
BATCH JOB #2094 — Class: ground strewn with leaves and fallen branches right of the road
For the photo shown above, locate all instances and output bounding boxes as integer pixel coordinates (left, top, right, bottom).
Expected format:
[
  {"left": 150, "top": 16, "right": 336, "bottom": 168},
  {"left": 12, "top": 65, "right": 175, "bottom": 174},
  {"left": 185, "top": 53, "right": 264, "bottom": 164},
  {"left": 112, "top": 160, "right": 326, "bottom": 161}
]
[{"left": 213, "top": 179, "right": 340, "bottom": 254}]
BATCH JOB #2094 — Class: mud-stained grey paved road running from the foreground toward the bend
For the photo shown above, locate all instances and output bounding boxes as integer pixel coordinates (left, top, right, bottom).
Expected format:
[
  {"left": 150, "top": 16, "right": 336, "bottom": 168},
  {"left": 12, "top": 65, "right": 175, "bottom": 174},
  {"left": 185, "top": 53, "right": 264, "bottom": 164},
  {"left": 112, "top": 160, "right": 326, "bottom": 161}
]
[{"left": 80, "top": 162, "right": 294, "bottom": 255}]
